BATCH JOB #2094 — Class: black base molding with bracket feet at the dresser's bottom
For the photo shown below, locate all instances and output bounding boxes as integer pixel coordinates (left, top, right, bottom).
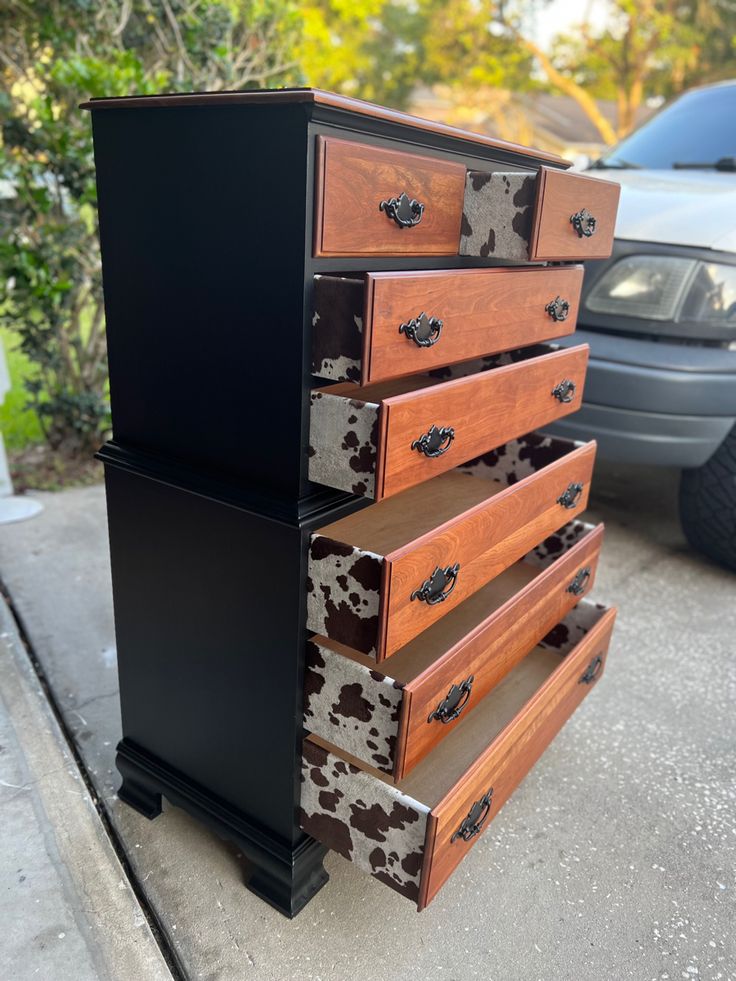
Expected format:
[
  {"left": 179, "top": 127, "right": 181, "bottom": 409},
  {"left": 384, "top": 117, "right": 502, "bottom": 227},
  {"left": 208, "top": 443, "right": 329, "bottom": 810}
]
[{"left": 115, "top": 739, "right": 329, "bottom": 918}]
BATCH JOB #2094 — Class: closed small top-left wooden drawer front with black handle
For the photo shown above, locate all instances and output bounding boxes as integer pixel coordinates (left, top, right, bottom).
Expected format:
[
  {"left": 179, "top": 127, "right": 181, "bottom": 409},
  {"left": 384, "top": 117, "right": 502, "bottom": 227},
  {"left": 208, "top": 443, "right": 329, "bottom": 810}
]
[{"left": 314, "top": 136, "right": 465, "bottom": 256}]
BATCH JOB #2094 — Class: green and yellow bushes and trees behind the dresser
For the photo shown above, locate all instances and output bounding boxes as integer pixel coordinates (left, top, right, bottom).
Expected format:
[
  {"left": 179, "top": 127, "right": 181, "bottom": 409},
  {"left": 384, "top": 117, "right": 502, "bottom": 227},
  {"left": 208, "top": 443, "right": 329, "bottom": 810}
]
[{"left": 0, "top": 0, "right": 736, "bottom": 478}]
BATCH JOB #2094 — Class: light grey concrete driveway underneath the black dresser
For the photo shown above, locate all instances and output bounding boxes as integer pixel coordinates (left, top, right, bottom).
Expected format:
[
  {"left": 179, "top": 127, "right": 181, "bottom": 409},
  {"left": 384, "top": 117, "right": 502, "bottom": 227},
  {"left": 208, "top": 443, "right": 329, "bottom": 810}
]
[{"left": 0, "top": 466, "right": 736, "bottom": 981}]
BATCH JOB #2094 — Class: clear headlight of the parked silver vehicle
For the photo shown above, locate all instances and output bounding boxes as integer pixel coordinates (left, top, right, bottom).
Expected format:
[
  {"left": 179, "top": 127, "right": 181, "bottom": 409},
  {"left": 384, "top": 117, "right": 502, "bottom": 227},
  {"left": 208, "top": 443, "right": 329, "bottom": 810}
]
[{"left": 586, "top": 255, "right": 736, "bottom": 327}]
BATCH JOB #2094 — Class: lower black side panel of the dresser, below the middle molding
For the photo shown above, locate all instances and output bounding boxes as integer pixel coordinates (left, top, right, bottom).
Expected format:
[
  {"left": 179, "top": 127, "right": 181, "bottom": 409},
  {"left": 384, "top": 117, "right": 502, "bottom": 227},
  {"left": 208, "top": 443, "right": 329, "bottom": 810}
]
[{"left": 105, "top": 464, "right": 340, "bottom": 842}]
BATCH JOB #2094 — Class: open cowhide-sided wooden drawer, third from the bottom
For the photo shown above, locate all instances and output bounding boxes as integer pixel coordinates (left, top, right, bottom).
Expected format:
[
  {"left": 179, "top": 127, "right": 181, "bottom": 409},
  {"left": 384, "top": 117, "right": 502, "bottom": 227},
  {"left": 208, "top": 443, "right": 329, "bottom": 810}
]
[{"left": 306, "top": 433, "right": 596, "bottom": 661}]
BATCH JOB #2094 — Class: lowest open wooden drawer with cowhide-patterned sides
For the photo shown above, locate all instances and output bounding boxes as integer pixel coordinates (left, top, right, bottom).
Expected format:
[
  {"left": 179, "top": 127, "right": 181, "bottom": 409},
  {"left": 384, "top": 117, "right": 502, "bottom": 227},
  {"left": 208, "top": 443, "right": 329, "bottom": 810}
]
[{"left": 300, "top": 600, "right": 615, "bottom": 909}]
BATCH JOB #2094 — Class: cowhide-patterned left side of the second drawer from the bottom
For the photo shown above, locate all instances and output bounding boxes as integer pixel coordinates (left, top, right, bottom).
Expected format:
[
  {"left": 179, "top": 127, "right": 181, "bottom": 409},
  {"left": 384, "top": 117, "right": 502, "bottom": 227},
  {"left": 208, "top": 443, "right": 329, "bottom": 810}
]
[{"left": 304, "top": 640, "right": 403, "bottom": 773}]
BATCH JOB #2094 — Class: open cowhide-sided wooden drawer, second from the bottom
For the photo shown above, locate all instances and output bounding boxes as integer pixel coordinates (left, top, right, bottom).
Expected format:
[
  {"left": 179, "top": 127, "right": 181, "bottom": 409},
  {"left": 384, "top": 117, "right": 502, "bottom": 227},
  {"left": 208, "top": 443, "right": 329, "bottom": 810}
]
[{"left": 304, "top": 521, "right": 603, "bottom": 780}]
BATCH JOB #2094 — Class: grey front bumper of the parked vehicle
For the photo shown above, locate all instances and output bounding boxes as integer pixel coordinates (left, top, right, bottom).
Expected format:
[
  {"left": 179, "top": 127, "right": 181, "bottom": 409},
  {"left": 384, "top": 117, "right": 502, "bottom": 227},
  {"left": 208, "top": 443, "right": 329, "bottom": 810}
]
[{"left": 548, "top": 327, "right": 736, "bottom": 467}]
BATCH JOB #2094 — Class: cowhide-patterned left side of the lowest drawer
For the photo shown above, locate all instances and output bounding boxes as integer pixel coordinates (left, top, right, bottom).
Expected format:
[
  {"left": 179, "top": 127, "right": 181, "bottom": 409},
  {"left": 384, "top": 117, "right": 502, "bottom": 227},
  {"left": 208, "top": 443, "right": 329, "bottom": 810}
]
[{"left": 300, "top": 740, "right": 429, "bottom": 901}]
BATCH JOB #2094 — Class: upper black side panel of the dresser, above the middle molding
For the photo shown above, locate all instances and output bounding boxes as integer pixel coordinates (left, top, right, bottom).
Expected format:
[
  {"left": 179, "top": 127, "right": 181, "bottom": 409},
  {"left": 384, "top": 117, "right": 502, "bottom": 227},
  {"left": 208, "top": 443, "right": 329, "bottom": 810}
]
[{"left": 92, "top": 104, "right": 311, "bottom": 497}]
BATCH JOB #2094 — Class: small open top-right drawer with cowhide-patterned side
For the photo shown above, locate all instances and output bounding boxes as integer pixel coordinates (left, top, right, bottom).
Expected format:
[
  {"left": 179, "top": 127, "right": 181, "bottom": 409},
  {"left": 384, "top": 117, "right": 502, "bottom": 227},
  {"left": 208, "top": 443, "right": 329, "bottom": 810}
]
[{"left": 460, "top": 167, "right": 621, "bottom": 262}]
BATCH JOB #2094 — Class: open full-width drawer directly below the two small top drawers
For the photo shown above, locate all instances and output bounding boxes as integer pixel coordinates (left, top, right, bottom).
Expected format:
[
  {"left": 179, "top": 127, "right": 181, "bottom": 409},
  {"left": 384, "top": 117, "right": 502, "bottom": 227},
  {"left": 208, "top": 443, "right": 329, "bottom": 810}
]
[{"left": 312, "top": 266, "right": 583, "bottom": 385}]
